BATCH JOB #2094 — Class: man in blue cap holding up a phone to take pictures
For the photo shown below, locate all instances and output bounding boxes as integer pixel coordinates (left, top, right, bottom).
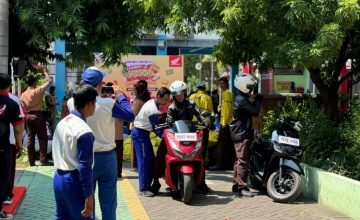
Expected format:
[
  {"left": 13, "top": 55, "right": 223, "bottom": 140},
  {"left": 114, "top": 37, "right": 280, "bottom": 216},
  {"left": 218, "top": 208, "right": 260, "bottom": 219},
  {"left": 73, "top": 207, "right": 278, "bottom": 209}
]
[{"left": 67, "top": 66, "right": 135, "bottom": 220}]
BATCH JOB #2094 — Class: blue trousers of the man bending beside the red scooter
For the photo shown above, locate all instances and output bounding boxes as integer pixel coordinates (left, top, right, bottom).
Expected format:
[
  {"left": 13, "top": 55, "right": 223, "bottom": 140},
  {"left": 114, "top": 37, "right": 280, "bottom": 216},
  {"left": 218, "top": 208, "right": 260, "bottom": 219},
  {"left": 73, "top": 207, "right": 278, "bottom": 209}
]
[{"left": 131, "top": 128, "right": 155, "bottom": 191}]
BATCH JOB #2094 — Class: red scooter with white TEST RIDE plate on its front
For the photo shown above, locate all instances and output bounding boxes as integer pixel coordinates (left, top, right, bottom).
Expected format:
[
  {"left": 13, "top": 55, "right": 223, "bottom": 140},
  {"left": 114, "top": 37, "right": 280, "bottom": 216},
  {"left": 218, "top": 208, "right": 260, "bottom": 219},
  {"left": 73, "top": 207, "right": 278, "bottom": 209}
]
[{"left": 157, "top": 120, "right": 205, "bottom": 204}]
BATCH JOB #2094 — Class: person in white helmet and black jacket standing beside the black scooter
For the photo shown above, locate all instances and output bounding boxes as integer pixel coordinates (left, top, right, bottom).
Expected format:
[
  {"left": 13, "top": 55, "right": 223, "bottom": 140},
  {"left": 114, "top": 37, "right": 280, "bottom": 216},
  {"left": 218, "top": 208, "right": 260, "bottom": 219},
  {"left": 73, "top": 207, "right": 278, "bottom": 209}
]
[{"left": 230, "top": 74, "right": 262, "bottom": 197}]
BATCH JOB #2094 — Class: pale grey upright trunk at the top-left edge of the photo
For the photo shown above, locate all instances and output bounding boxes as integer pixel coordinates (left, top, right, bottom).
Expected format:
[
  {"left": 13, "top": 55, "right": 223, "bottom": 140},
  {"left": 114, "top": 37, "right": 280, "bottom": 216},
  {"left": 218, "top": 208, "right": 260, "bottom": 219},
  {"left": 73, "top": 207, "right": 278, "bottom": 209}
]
[{"left": 0, "top": 0, "right": 9, "bottom": 73}]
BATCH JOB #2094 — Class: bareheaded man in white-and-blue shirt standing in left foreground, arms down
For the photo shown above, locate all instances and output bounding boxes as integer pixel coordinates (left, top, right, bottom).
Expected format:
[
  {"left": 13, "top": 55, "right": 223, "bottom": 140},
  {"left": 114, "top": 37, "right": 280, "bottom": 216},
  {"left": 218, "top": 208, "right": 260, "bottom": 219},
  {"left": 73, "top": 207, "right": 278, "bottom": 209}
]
[{"left": 52, "top": 85, "right": 97, "bottom": 219}]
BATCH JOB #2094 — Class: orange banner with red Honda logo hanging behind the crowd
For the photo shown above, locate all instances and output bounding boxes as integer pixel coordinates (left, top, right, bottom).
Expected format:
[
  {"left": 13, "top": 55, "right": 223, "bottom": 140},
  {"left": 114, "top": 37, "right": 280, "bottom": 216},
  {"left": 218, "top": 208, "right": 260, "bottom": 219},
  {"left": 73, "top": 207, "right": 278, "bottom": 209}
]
[{"left": 95, "top": 55, "right": 184, "bottom": 98}]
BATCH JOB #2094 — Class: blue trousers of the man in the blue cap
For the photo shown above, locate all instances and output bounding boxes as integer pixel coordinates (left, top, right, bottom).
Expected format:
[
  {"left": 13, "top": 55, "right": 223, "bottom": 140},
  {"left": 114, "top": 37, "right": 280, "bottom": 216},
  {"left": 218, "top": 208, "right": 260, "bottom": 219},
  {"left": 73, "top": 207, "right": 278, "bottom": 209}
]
[{"left": 93, "top": 150, "right": 118, "bottom": 220}]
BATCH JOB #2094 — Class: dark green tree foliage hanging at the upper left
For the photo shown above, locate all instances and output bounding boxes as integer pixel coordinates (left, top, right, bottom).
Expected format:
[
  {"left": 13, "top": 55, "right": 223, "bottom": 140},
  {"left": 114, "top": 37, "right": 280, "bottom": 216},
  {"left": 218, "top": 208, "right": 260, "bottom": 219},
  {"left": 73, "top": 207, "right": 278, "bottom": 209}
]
[{"left": 11, "top": 0, "right": 155, "bottom": 67}]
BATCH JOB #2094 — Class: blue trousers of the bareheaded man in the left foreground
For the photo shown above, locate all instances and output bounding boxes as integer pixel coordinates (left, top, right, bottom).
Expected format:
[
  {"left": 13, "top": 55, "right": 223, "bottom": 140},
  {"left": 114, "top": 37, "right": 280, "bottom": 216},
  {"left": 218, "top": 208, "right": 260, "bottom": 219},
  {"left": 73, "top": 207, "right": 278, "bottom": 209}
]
[{"left": 53, "top": 170, "right": 91, "bottom": 220}]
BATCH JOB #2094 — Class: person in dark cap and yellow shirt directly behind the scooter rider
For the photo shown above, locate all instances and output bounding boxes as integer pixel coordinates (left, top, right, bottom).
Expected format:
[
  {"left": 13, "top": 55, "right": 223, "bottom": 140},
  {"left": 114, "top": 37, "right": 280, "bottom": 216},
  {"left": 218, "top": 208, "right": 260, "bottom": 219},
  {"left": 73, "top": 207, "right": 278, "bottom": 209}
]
[{"left": 189, "top": 82, "right": 214, "bottom": 167}]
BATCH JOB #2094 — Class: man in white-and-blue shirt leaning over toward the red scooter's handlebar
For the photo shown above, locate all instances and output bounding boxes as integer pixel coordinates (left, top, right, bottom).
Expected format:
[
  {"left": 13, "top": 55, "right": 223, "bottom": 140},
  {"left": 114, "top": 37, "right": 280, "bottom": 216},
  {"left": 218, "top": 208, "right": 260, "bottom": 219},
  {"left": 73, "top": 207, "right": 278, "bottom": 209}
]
[{"left": 131, "top": 87, "right": 170, "bottom": 197}]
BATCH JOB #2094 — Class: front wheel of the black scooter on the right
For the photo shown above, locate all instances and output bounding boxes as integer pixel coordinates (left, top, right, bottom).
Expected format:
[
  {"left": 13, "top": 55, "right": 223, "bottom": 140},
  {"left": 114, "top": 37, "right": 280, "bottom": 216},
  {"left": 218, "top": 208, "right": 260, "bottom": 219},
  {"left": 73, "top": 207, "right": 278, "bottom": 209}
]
[{"left": 266, "top": 169, "right": 302, "bottom": 203}]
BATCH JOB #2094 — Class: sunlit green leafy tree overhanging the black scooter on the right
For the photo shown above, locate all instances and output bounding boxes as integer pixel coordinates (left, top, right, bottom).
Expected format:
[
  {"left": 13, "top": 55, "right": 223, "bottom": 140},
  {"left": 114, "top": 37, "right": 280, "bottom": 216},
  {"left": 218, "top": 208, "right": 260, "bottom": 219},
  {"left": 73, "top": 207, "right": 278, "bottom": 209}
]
[{"left": 136, "top": 0, "right": 360, "bottom": 122}]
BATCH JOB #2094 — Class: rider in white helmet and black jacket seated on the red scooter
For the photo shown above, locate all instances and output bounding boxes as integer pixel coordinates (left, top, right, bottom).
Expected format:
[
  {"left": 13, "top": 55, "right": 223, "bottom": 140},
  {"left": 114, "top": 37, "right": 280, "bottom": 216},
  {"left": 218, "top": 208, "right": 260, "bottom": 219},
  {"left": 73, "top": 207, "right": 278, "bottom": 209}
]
[{"left": 151, "top": 80, "right": 211, "bottom": 194}]
